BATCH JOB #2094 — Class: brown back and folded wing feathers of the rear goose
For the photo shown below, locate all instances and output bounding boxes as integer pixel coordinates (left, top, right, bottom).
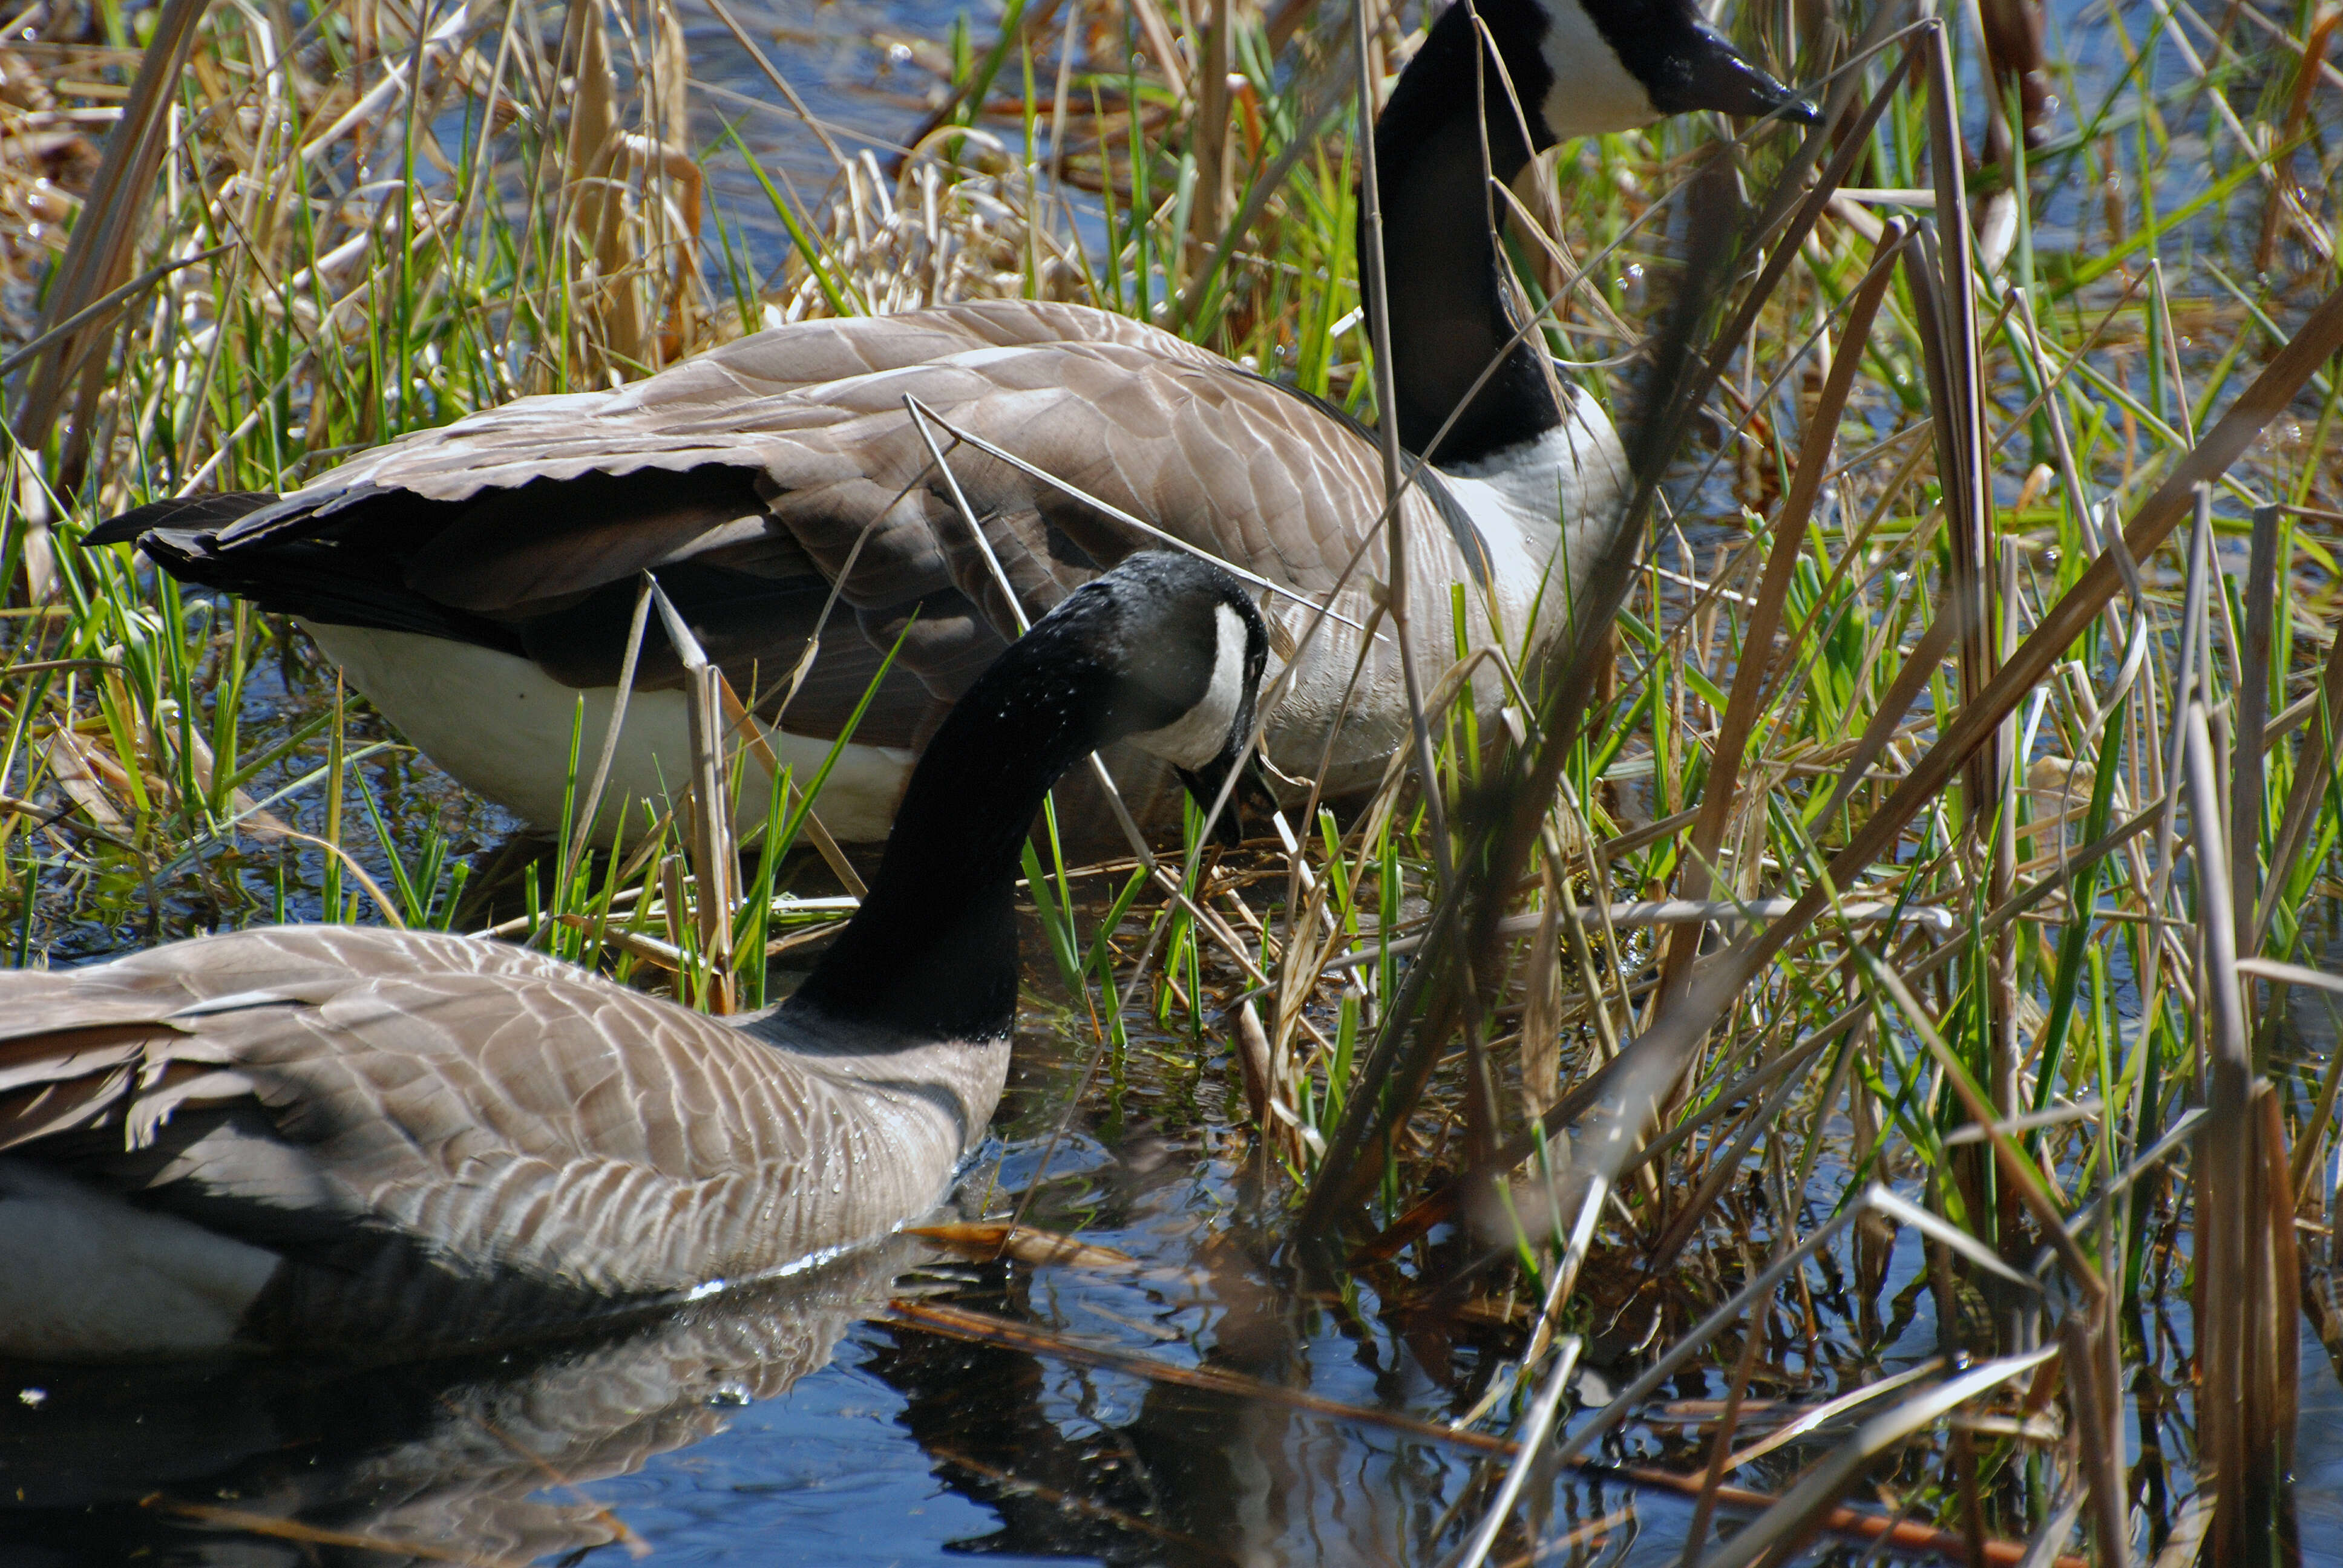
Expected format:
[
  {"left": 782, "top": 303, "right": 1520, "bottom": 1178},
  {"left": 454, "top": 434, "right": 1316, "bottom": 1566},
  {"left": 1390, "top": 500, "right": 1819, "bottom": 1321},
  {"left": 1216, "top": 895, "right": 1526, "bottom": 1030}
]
[{"left": 173, "top": 302, "right": 1443, "bottom": 743}]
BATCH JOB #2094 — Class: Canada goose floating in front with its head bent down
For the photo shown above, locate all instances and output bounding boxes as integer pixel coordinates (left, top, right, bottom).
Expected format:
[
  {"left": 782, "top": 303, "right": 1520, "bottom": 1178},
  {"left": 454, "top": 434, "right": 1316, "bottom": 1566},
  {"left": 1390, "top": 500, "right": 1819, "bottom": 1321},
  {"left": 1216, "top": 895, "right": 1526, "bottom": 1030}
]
[{"left": 0, "top": 553, "right": 1268, "bottom": 1357}]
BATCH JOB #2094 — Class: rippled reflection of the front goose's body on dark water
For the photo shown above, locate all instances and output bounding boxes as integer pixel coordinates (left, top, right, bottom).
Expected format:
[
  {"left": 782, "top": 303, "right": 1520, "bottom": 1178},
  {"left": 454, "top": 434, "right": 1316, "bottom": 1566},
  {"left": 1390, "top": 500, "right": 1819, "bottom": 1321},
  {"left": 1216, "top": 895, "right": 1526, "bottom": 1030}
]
[{"left": 0, "top": 1238, "right": 935, "bottom": 1568}]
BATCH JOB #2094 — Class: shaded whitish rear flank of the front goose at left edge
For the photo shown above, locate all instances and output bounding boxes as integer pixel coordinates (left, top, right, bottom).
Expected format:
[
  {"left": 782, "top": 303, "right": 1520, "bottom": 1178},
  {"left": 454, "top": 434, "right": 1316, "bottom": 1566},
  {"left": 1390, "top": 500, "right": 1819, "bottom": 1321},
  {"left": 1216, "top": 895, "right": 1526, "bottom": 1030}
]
[{"left": 0, "top": 1160, "right": 279, "bottom": 1359}]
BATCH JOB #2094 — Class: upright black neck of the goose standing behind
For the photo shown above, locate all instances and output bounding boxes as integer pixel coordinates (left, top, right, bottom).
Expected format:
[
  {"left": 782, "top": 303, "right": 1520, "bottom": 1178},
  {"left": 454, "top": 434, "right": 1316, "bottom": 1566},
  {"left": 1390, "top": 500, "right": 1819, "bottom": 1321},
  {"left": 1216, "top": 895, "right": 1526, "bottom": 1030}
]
[{"left": 1359, "top": 0, "right": 1563, "bottom": 466}]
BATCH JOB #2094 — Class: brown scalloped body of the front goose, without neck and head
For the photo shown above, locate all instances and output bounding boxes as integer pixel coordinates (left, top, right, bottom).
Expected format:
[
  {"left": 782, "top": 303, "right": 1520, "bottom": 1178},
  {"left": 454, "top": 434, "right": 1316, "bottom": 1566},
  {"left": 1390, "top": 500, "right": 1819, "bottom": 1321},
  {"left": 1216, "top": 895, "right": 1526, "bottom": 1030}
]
[{"left": 0, "top": 928, "right": 1008, "bottom": 1354}]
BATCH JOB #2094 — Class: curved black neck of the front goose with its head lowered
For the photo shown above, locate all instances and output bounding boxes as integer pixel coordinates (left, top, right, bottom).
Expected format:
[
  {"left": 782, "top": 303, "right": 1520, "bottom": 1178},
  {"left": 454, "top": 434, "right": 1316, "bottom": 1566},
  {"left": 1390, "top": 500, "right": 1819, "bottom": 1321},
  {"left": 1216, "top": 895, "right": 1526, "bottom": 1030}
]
[{"left": 785, "top": 633, "right": 1115, "bottom": 1043}]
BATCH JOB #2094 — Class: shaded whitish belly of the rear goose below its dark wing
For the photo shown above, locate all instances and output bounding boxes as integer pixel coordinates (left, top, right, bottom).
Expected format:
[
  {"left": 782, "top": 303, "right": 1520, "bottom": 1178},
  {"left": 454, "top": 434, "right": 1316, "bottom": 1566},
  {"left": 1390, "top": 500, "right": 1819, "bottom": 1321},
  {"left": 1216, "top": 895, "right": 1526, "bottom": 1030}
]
[{"left": 316, "top": 621, "right": 914, "bottom": 844}]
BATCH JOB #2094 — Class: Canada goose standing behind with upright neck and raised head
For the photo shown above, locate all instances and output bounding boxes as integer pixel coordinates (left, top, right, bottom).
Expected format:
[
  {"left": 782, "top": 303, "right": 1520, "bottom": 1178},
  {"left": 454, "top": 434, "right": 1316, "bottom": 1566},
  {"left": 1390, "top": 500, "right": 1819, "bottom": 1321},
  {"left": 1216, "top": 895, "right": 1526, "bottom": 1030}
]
[{"left": 89, "top": 0, "right": 1814, "bottom": 841}]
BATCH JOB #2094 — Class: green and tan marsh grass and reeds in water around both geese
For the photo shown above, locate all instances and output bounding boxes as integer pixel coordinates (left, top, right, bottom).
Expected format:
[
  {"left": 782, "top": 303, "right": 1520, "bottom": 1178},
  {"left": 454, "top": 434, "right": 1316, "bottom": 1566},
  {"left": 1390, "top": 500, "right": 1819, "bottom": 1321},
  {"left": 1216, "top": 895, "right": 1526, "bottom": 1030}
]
[{"left": 0, "top": 0, "right": 2343, "bottom": 1566}]
